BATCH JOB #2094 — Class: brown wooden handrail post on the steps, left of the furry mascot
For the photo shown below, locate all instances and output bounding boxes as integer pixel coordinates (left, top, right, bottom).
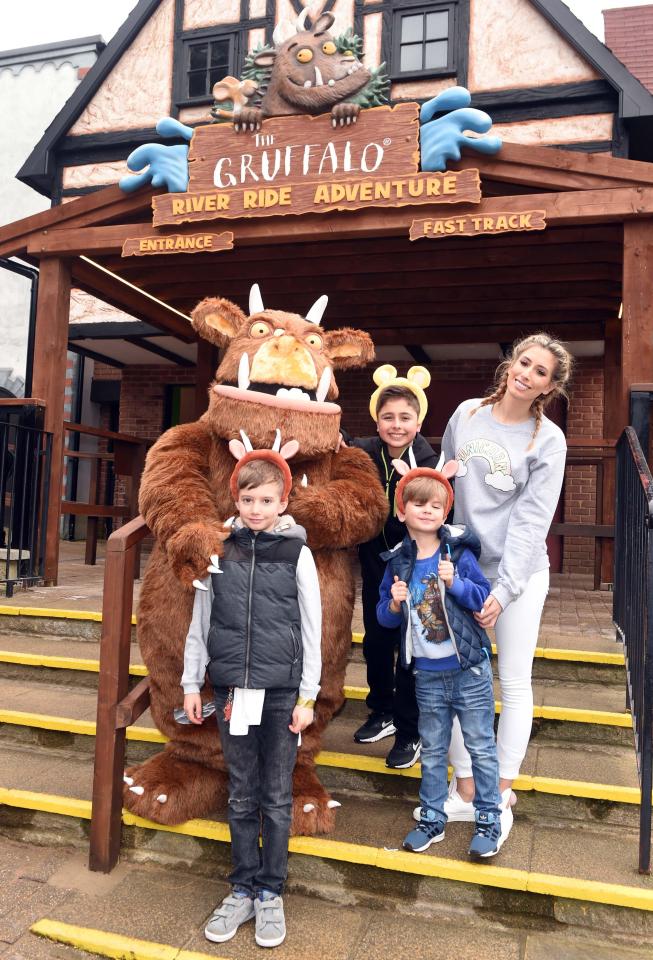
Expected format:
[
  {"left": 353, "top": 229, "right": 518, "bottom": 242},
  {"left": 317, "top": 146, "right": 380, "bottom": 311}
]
[{"left": 89, "top": 516, "right": 149, "bottom": 873}]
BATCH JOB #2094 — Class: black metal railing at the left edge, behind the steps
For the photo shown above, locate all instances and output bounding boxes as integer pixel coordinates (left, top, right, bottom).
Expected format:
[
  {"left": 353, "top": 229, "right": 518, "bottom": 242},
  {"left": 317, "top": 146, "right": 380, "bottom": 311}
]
[{"left": 0, "top": 420, "right": 52, "bottom": 597}]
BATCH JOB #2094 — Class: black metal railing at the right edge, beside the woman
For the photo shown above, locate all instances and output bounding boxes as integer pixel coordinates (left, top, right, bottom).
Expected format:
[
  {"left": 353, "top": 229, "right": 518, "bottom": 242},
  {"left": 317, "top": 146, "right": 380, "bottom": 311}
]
[{"left": 612, "top": 427, "right": 653, "bottom": 873}]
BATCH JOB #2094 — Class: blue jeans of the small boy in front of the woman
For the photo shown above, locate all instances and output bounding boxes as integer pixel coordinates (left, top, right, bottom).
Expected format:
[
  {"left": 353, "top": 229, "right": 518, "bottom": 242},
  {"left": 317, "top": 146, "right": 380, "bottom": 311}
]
[{"left": 415, "top": 657, "right": 501, "bottom": 823}]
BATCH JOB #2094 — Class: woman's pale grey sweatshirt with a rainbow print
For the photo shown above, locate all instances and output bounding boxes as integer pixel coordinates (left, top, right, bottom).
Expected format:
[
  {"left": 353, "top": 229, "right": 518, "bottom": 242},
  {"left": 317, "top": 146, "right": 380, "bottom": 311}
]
[{"left": 442, "top": 399, "right": 567, "bottom": 610}]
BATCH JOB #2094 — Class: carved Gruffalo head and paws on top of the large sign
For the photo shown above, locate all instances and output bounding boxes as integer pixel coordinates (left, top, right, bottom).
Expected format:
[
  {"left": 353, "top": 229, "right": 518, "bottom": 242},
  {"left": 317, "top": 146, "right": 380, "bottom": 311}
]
[{"left": 235, "top": 9, "right": 371, "bottom": 129}]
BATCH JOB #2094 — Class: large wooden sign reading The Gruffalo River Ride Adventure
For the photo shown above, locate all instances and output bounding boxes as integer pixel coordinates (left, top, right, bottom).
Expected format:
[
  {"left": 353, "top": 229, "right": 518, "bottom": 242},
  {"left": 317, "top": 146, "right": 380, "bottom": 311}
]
[{"left": 152, "top": 103, "right": 481, "bottom": 227}]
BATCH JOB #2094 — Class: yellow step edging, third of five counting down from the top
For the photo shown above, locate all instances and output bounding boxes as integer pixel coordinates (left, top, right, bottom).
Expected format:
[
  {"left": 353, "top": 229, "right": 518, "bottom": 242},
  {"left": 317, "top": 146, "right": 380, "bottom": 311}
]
[{"left": 0, "top": 710, "right": 640, "bottom": 805}]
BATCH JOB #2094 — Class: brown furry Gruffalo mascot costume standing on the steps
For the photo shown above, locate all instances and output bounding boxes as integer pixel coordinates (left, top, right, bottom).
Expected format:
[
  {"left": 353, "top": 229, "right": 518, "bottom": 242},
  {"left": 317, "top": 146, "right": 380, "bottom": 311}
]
[{"left": 124, "top": 287, "right": 387, "bottom": 834}]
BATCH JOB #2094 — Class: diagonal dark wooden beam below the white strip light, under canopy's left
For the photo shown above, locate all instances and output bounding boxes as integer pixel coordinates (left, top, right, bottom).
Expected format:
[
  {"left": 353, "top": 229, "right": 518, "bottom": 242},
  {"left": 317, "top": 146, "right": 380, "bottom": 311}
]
[{"left": 72, "top": 259, "right": 196, "bottom": 343}]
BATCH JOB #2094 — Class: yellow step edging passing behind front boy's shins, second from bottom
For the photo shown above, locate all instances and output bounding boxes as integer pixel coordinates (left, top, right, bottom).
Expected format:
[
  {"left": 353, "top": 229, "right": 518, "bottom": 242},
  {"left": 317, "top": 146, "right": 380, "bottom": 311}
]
[{"left": 0, "top": 788, "right": 653, "bottom": 911}]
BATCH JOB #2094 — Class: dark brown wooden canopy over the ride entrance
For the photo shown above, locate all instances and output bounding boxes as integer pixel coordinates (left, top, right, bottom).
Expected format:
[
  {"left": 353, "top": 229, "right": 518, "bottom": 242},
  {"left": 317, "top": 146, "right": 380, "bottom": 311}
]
[{"left": 0, "top": 144, "right": 653, "bottom": 575}]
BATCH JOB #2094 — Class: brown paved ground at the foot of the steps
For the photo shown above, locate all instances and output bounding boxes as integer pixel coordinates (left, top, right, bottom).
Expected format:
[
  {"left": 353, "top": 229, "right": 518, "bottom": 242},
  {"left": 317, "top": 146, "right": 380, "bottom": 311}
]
[{"left": 0, "top": 837, "right": 650, "bottom": 960}]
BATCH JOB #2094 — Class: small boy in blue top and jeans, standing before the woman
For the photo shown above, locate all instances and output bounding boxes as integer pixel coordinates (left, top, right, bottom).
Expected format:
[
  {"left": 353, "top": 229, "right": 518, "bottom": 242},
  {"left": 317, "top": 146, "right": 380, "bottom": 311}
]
[{"left": 377, "top": 461, "right": 512, "bottom": 858}]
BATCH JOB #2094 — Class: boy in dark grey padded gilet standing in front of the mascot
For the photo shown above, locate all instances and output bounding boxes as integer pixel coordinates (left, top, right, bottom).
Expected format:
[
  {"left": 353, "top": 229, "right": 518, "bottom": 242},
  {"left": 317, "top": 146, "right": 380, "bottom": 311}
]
[{"left": 182, "top": 430, "right": 320, "bottom": 947}]
